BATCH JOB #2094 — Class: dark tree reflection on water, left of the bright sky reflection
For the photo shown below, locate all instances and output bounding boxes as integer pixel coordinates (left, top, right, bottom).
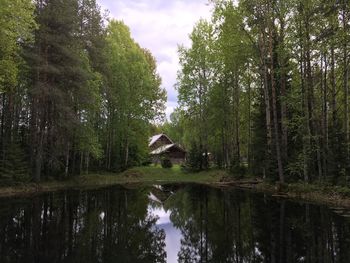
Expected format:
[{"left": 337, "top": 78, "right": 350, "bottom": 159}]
[{"left": 0, "top": 189, "right": 166, "bottom": 263}]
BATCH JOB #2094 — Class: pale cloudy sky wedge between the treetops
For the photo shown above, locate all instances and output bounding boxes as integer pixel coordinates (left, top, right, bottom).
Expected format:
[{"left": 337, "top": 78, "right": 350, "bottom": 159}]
[{"left": 98, "top": 0, "right": 211, "bottom": 117}]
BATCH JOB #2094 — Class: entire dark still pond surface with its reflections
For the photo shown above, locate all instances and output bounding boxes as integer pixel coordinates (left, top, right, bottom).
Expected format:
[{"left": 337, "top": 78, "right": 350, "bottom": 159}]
[{"left": 0, "top": 185, "right": 350, "bottom": 263}]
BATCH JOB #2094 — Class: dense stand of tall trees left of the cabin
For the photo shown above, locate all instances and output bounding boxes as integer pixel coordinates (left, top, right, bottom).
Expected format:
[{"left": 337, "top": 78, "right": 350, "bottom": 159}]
[{"left": 0, "top": 0, "right": 165, "bottom": 181}]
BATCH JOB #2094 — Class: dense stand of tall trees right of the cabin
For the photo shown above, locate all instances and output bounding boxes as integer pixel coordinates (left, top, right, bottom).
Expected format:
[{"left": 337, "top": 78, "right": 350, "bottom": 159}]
[{"left": 174, "top": 0, "right": 350, "bottom": 186}]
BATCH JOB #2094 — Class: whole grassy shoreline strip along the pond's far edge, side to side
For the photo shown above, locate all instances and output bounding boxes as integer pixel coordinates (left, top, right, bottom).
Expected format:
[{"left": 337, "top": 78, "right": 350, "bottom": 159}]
[{"left": 0, "top": 167, "right": 350, "bottom": 209}]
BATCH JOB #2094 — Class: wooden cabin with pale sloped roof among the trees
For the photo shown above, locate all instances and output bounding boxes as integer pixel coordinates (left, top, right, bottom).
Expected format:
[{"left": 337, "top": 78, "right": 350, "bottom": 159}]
[{"left": 149, "top": 134, "right": 186, "bottom": 164}]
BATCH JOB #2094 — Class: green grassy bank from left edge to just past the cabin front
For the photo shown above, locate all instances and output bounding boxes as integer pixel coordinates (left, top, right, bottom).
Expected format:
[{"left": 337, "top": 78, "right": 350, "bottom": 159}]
[{"left": 0, "top": 165, "right": 227, "bottom": 197}]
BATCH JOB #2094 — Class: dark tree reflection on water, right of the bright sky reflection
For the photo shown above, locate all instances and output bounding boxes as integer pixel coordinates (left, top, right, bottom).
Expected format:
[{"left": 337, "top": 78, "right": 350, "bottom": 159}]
[{"left": 165, "top": 186, "right": 350, "bottom": 263}]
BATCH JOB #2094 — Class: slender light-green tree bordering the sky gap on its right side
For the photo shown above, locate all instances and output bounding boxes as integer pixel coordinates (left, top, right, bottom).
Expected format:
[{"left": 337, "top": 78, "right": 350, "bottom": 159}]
[{"left": 176, "top": 20, "right": 214, "bottom": 170}]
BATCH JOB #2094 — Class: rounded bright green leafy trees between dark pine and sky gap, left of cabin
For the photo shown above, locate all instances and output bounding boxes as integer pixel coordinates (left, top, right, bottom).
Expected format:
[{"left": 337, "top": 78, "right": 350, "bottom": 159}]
[{"left": 105, "top": 20, "right": 166, "bottom": 170}]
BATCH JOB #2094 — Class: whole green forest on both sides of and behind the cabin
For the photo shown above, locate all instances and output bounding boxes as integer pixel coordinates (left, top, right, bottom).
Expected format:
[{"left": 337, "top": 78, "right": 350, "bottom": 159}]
[{"left": 0, "top": 0, "right": 350, "bottom": 188}]
